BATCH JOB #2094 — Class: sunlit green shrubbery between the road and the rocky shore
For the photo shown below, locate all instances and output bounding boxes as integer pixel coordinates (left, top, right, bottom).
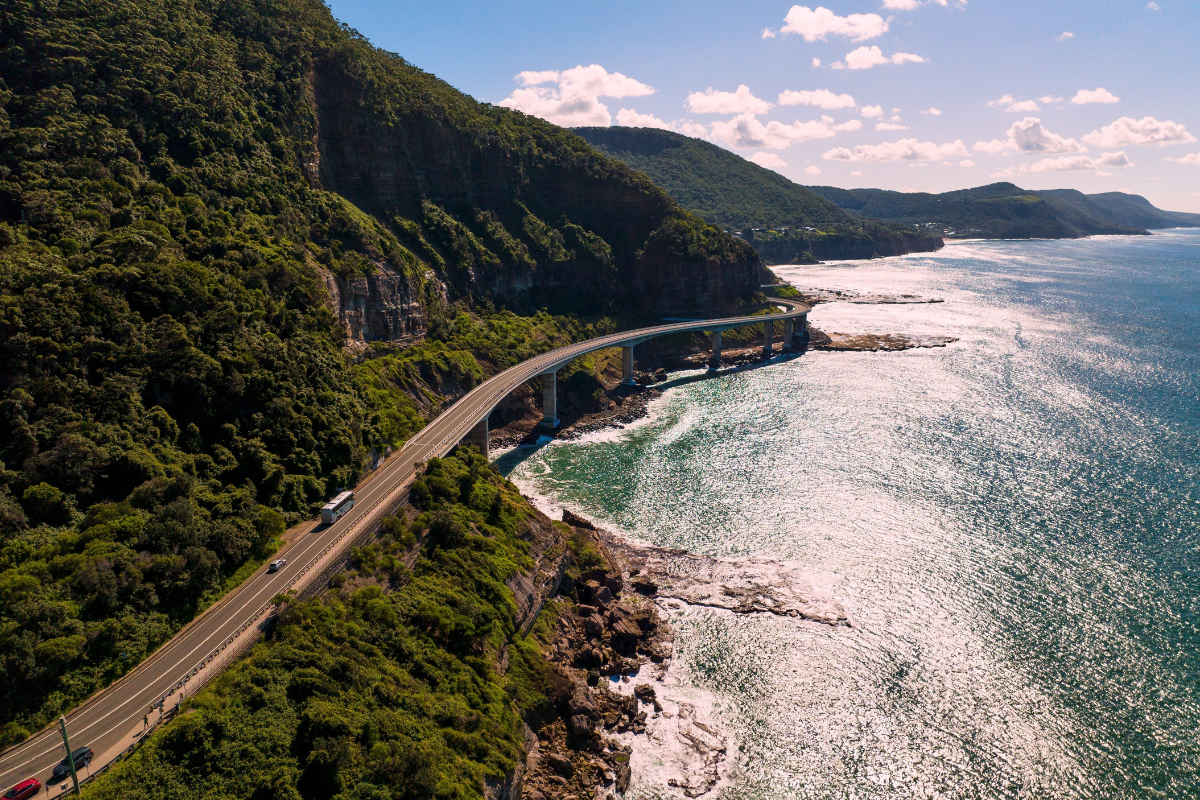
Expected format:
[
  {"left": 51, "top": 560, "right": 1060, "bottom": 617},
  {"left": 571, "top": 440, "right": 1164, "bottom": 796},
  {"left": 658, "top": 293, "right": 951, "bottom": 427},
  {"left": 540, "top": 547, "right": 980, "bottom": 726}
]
[{"left": 86, "top": 449, "right": 566, "bottom": 800}]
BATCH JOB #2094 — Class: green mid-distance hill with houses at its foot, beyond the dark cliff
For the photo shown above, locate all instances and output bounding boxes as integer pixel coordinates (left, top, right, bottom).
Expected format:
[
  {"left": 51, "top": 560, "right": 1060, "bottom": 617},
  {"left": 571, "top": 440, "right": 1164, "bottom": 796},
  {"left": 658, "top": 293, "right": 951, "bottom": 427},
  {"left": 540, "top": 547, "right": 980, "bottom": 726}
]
[{"left": 575, "top": 127, "right": 942, "bottom": 264}]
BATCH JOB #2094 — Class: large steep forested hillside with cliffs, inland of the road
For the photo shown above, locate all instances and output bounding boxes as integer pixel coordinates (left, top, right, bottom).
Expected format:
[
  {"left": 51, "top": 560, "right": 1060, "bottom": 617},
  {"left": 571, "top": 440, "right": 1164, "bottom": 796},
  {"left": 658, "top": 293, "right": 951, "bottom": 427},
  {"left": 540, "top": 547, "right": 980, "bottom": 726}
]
[{"left": 0, "top": 0, "right": 758, "bottom": 745}]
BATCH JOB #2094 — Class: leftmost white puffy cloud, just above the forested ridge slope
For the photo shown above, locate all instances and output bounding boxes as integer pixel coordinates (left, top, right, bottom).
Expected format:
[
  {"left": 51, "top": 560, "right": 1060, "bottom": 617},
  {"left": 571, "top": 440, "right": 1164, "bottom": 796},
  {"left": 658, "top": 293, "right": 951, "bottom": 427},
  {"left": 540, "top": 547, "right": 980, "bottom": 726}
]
[{"left": 499, "top": 64, "right": 654, "bottom": 127}]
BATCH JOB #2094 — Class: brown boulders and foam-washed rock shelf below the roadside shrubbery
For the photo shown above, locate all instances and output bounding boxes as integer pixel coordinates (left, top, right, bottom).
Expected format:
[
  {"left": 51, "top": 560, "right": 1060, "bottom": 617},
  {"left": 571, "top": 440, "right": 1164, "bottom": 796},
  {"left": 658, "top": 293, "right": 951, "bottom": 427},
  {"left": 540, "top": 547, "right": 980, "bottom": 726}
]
[{"left": 516, "top": 509, "right": 856, "bottom": 800}]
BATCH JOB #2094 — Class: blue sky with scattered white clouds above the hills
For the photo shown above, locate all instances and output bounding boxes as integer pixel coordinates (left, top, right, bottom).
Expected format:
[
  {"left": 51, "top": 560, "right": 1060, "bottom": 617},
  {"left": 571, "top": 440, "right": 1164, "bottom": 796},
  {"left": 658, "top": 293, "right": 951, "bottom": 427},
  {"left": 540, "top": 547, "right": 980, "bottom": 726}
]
[{"left": 331, "top": 0, "right": 1200, "bottom": 211}]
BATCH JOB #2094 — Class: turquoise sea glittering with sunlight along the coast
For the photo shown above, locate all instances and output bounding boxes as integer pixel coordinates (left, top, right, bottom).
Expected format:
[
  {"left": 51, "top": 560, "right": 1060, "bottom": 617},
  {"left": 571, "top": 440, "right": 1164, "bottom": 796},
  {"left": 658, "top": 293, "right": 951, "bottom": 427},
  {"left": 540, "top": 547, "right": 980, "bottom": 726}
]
[{"left": 496, "top": 231, "right": 1200, "bottom": 800}]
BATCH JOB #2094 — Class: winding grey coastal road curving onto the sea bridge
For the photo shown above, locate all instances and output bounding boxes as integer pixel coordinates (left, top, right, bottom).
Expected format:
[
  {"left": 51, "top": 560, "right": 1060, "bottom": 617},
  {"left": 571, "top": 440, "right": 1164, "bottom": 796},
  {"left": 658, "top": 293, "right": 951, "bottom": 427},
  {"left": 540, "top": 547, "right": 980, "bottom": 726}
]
[{"left": 0, "top": 299, "right": 809, "bottom": 796}]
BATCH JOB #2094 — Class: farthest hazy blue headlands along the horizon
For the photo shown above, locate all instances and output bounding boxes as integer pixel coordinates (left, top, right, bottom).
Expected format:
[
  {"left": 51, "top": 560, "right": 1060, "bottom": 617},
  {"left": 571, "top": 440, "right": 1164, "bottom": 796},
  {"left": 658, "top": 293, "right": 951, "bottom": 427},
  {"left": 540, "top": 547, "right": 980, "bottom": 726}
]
[{"left": 809, "top": 182, "right": 1200, "bottom": 239}]
